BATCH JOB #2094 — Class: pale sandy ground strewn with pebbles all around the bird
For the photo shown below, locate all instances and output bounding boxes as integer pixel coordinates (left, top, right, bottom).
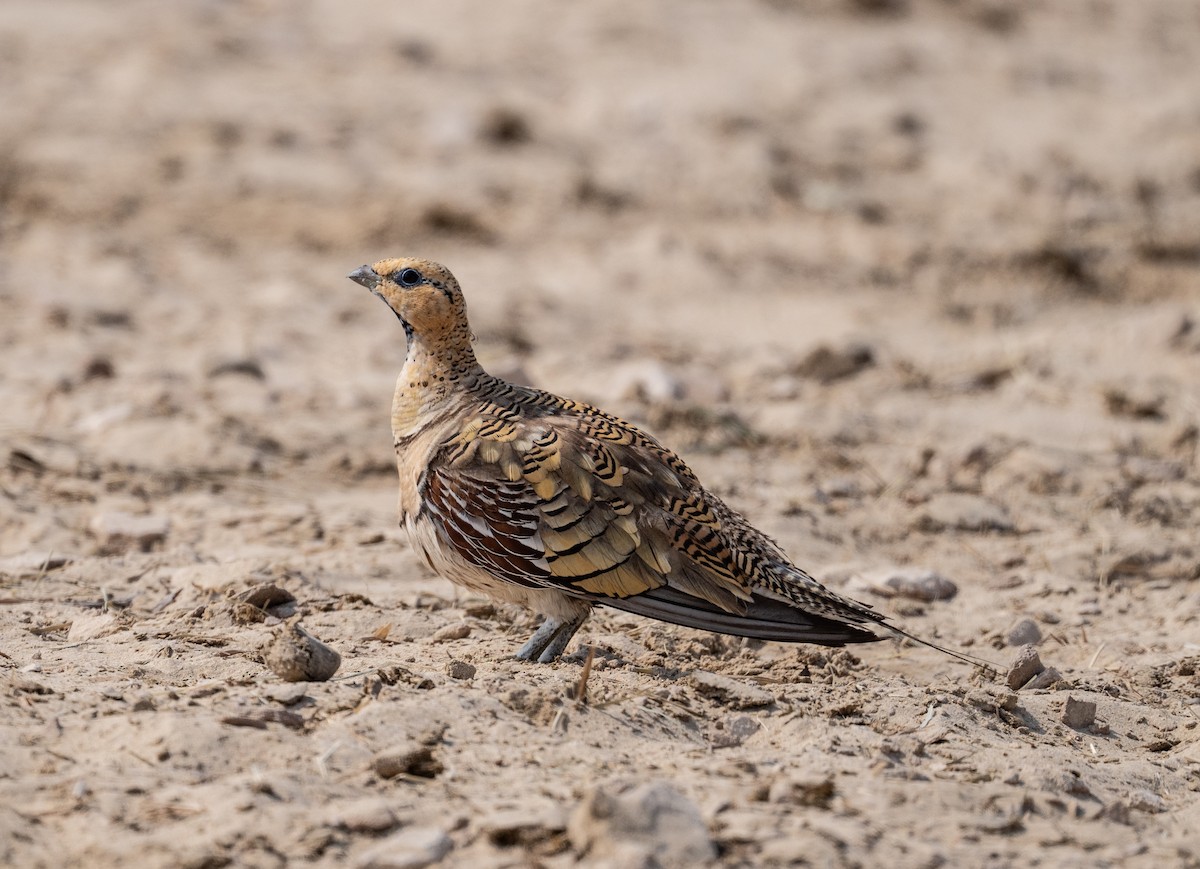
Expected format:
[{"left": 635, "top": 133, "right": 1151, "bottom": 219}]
[{"left": 0, "top": 0, "right": 1200, "bottom": 869}]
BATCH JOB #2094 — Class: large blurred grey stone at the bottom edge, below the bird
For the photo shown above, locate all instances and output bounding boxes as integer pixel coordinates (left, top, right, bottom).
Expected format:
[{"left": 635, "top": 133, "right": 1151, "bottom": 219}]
[{"left": 566, "top": 781, "right": 716, "bottom": 869}]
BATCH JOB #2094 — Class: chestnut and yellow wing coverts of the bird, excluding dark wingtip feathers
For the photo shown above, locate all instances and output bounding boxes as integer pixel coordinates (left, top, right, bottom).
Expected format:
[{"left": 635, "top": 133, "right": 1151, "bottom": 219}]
[{"left": 422, "top": 414, "right": 671, "bottom": 598}]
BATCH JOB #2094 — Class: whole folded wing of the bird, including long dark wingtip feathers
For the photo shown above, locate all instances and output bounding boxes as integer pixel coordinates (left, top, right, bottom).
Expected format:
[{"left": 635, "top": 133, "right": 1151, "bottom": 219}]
[{"left": 421, "top": 392, "right": 878, "bottom": 645}]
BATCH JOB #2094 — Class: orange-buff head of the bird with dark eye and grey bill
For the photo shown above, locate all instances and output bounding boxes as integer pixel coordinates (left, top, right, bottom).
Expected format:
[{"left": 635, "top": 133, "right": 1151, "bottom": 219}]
[{"left": 349, "top": 257, "right": 470, "bottom": 343}]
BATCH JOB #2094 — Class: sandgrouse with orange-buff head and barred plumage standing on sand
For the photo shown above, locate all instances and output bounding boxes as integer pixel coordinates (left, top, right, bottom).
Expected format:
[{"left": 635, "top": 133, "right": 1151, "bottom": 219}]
[{"left": 349, "top": 258, "right": 984, "bottom": 663}]
